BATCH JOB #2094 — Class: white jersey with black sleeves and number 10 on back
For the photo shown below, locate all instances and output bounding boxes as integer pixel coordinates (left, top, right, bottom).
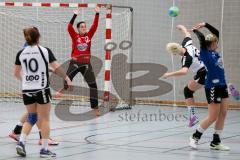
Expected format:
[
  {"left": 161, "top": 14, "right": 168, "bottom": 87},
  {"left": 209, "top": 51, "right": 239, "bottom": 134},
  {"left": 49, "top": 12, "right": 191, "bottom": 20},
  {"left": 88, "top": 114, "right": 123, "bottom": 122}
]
[{"left": 15, "top": 45, "right": 56, "bottom": 93}]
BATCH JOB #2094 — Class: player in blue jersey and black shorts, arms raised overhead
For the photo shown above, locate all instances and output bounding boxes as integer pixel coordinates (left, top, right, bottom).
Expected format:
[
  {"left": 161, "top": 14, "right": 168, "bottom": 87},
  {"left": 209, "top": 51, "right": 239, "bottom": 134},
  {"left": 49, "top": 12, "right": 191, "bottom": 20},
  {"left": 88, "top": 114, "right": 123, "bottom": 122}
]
[{"left": 189, "top": 22, "right": 230, "bottom": 150}]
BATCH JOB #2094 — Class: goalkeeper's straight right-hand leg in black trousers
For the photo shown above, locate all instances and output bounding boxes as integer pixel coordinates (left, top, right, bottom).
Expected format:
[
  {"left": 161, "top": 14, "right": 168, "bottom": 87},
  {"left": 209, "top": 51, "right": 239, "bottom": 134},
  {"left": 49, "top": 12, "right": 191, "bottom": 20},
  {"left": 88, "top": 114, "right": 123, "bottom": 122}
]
[{"left": 80, "top": 64, "right": 100, "bottom": 116}]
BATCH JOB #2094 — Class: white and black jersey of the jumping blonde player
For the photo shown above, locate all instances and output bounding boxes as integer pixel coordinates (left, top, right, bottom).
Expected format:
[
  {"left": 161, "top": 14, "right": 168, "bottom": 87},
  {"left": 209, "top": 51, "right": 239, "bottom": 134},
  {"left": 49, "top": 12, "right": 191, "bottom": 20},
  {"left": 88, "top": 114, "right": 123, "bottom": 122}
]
[{"left": 182, "top": 37, "right": 205, "bottom": 73}]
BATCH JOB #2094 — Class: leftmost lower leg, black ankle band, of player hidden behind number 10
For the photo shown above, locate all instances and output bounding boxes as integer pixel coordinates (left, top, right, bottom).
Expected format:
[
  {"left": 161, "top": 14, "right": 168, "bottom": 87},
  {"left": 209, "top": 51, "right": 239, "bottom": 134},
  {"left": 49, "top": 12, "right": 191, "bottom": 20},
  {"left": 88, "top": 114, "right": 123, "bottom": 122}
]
[{"left": 9, "top": 112, "right": 28, "bottom": 141}]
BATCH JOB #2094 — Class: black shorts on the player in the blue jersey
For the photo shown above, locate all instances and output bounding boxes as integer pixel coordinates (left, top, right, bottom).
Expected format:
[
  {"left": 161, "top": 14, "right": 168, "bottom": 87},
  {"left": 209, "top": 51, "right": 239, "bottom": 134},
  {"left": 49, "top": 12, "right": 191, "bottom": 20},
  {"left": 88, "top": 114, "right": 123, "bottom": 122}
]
[{"left": 205, "top": 85, "right": 228, "bottom": 104}]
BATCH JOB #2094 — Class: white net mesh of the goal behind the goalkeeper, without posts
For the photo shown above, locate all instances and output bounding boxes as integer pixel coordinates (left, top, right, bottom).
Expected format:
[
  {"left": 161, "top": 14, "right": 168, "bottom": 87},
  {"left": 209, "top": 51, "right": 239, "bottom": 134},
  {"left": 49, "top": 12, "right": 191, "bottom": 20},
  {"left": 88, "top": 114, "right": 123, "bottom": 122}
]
[{"left": 0, "top": 4, "right": 131, "bottom": 109}]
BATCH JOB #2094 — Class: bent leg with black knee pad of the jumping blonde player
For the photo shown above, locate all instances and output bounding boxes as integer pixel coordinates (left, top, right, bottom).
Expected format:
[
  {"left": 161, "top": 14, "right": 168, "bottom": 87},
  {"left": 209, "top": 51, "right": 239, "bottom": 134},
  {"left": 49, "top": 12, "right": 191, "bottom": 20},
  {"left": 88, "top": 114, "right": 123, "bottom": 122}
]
[{"left": 184, "top": 80, "right": 203, "bottom": 127}]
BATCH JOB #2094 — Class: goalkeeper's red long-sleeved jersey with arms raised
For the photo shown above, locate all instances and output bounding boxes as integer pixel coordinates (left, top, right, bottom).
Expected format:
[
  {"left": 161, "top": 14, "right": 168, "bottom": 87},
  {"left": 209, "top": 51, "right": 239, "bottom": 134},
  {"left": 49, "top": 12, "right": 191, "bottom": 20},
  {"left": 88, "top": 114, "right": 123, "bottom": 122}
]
[{"left": 68, "top": 14, "right": 99, "bottom": 63}]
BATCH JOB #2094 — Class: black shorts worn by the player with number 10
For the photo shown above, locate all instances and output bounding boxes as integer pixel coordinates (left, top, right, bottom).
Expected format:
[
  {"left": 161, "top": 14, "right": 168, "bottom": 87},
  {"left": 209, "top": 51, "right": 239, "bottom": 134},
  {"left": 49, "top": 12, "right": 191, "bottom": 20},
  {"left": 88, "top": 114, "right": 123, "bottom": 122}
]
[{"left": 23, "top": 88, "right": 52, "bottom": 105}]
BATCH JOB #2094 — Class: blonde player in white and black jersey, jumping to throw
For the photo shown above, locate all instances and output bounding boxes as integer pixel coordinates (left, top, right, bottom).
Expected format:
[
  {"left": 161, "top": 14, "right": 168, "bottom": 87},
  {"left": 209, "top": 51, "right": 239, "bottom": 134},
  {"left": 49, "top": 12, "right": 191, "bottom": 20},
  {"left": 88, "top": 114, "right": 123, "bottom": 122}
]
[{"left": 163, "top": 25, "right": 206, "bottom": 127}]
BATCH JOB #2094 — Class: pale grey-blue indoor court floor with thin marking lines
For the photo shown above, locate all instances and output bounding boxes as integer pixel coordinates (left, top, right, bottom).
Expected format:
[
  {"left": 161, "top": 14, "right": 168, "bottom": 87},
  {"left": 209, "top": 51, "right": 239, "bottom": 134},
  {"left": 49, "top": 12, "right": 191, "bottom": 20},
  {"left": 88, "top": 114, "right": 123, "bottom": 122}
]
[{"left": 0, "top": 103, "right": 240, "bottom": 160}]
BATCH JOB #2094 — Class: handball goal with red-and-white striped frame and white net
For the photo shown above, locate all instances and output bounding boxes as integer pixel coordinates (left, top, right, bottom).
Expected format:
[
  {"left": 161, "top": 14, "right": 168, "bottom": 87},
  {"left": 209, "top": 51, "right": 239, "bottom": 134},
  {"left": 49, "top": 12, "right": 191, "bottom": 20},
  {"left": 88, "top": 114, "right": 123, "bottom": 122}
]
[{"left": 0, "top": 2, "right": 132, "bottom": 110}]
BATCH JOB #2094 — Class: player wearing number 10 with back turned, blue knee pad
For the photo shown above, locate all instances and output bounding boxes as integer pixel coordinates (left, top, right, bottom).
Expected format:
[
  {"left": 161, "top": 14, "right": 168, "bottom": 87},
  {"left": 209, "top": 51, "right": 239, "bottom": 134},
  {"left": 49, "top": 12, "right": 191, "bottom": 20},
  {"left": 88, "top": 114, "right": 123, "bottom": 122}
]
[{"left": 14, "top": 27, "right": 72, "bottom": 157}]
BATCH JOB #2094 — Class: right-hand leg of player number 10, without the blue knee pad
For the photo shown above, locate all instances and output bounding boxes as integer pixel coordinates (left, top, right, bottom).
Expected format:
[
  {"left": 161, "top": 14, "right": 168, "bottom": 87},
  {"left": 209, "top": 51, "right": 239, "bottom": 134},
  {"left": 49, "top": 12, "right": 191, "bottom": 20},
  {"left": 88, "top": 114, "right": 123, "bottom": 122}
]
[{"left": 37, "top": 89, "right": 56, "bottom": 158}]
